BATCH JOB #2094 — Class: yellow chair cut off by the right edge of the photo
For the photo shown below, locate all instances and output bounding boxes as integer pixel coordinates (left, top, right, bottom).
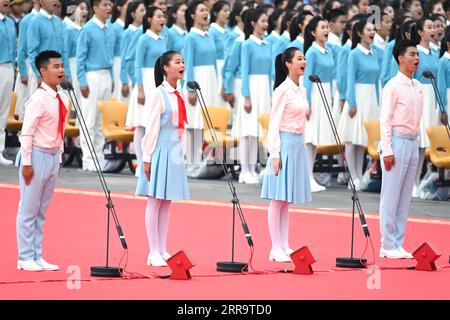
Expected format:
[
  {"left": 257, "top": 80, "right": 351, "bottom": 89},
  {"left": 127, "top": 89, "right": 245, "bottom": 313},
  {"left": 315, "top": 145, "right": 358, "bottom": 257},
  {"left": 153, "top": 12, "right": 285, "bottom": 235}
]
[{"left": 427, "top": 126, "right": 450, "bottom": 169}]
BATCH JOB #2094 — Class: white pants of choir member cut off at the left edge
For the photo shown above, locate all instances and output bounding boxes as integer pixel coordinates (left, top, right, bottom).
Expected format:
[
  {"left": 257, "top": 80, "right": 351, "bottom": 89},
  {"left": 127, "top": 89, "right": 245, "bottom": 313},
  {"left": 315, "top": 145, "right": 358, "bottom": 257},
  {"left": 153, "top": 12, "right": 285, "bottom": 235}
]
[{"left": 0, "top": 63, "right": 14, "bottom": 154}]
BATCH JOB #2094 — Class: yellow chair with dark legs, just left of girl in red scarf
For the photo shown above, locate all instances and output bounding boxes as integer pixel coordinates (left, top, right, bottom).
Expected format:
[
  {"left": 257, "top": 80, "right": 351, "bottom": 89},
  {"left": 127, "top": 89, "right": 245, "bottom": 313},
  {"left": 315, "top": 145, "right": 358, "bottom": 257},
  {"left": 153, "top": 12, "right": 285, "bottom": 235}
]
[{"left": 98, "top": 100, "right": 136, "bottom": 173}]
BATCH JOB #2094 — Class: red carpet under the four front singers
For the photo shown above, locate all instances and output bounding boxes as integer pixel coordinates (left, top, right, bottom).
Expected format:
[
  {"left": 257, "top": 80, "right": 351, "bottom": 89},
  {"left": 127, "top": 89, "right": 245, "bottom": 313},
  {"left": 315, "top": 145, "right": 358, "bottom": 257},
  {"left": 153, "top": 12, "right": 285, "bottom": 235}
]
[{"left": 0, "top": 184, "right": 450, "bottom": 300}]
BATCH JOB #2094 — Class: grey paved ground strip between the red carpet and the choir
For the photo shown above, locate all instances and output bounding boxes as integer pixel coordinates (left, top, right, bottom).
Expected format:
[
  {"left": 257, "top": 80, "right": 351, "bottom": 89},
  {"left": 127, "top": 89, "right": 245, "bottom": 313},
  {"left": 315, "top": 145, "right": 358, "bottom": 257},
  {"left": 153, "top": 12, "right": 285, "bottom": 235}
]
[{"left": 0, "top": 158, "right": 450, "bottom": 219}]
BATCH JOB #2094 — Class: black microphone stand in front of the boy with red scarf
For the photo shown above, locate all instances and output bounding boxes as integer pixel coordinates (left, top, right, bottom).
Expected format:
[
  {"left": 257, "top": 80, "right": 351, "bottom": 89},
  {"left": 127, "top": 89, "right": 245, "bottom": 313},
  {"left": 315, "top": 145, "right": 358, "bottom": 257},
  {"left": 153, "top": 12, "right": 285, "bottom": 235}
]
[{"left": 61, "top": 81, "right": 128, "bottom": 278}]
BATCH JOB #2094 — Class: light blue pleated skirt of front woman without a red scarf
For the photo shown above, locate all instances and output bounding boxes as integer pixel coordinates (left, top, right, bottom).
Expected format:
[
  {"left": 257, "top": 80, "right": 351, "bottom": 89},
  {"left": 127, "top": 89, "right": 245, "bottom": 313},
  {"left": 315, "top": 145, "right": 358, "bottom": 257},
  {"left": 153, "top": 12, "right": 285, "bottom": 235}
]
[{"left": 261, "top": 131, "right": 311, "bottom": 204}]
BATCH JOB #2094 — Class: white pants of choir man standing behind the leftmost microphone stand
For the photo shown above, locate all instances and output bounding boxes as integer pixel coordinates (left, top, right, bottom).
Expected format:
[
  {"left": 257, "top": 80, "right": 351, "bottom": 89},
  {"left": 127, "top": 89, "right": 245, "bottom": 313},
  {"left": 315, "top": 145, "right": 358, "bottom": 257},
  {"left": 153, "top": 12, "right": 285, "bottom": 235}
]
[{"left": 80, "top": 70, "right": 112, "bottom": 168}]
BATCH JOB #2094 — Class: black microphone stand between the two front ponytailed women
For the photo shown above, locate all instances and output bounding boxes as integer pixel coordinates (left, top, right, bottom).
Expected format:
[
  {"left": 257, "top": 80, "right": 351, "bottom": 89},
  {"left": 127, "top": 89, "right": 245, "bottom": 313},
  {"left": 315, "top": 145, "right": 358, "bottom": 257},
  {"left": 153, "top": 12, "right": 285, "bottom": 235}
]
[{"left": 188, "top": 81, "right": 253, "bottom": 273}]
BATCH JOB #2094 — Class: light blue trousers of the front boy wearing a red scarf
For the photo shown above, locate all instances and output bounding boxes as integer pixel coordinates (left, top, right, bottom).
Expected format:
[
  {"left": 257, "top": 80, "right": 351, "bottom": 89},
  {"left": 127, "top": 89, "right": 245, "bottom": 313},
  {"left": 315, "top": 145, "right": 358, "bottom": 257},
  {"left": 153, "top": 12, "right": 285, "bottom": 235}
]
[{"left": 16, "top": 147, "right": 60, "bottom": 260}]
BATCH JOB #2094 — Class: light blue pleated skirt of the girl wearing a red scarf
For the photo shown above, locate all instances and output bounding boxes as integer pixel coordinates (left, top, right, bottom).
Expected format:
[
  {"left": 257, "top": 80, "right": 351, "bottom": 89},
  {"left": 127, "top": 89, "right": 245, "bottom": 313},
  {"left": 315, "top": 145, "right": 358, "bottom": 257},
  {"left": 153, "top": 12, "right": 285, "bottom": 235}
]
[{"left": 136, "top": 134, "right": 190, "bottom": 200}]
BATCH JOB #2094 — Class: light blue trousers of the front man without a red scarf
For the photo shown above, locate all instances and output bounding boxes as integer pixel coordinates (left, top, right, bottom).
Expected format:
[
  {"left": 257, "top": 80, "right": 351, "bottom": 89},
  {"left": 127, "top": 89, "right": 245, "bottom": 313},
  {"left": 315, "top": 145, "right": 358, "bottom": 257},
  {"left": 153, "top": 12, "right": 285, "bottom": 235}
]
[{"left": 380, "top": 132, "right": 419, "bottom": 250}]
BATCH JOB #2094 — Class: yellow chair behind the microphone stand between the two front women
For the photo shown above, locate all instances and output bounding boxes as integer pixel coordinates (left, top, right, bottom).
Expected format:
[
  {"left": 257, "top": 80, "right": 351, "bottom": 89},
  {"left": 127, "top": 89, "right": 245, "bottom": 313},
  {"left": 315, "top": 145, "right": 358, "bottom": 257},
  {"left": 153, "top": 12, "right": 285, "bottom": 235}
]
[{"left": 202, "top": 106, "right": 239, "bottom": 149}]
